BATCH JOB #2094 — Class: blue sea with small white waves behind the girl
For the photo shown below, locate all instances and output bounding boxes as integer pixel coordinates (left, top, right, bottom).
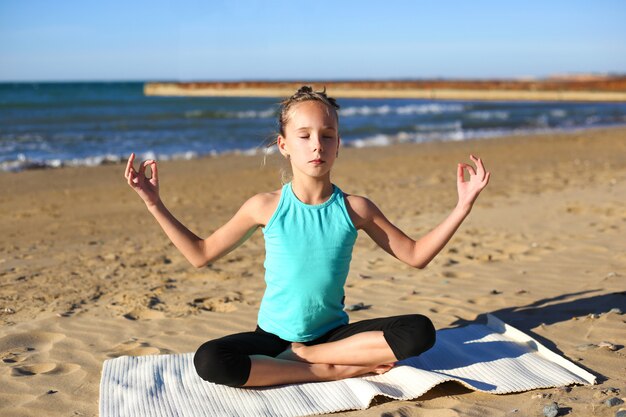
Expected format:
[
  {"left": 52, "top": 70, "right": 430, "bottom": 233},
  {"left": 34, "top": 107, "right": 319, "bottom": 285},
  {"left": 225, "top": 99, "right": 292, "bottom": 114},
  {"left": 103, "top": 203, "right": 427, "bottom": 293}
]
[{"left": 0, "top": 82, "right": 626, "bottom": 171}]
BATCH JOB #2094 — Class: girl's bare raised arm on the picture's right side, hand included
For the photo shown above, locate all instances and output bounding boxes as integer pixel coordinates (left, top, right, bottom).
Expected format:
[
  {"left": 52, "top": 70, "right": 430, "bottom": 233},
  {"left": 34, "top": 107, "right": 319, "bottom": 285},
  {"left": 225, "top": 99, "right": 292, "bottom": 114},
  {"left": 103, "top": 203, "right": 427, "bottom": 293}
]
[{"left": 362, "top": 155, "right": 490, "bottom": 269}]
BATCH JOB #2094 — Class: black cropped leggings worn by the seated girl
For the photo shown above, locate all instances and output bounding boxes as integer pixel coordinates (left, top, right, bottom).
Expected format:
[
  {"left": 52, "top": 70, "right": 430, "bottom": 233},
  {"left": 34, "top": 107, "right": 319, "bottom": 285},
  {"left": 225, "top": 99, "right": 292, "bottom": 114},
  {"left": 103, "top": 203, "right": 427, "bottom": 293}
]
[{"left": 193, "top": 314, "right": 435, "bottom": 387}]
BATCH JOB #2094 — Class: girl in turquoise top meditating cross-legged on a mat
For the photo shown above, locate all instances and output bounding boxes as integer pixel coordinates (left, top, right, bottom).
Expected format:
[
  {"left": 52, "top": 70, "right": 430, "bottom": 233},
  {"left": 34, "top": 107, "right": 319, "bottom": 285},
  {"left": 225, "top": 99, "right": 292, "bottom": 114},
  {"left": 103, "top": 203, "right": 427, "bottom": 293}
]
[{"left": 125, "top": 87, "right": 489, "bottom": 387}]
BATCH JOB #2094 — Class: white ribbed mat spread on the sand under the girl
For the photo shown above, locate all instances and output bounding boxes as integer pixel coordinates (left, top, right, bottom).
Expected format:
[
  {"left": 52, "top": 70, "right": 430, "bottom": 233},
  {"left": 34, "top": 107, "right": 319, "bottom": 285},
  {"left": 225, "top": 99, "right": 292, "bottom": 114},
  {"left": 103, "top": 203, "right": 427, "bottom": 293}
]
[{"left": 100, "top": 316, "right": 596, "bottom": 417}]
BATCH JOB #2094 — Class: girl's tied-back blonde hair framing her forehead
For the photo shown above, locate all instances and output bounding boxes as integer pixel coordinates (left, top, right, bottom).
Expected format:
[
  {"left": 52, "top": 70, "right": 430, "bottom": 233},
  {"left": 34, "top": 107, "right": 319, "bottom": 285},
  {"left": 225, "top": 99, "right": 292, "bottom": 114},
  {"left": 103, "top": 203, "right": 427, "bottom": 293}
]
[{"left": 263, "top": 85, "right": 339, "bottom": 185}]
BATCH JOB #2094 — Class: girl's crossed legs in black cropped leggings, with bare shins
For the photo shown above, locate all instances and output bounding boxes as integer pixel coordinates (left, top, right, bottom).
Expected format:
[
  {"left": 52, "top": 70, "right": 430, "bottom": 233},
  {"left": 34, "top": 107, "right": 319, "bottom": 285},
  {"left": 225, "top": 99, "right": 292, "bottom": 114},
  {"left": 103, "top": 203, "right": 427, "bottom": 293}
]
[{"left": 194, "top": 315, "right": 435, "bottom": 387}]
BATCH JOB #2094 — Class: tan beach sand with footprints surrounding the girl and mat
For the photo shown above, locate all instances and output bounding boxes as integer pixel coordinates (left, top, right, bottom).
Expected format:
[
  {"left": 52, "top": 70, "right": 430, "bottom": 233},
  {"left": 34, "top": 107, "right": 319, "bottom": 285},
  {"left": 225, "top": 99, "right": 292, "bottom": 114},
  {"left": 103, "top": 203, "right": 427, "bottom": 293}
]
[{"left": 0, "top": 128, "right": 626, "bottom": 416}]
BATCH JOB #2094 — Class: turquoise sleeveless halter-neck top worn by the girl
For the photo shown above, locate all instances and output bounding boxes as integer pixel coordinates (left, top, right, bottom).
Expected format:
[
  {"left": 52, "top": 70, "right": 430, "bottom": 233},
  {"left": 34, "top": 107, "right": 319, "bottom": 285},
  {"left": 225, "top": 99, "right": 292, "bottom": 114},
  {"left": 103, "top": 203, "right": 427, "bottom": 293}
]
[{"left": 258, "top": 182, "right": 358, "bottom": 342}]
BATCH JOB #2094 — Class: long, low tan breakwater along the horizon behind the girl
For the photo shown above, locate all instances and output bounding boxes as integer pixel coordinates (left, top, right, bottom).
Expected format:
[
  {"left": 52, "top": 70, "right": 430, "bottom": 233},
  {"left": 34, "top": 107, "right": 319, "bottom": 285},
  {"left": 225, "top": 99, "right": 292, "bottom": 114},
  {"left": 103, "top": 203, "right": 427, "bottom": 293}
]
[{"left": 144, "top": 77, "right": 626, "bottom": 102}]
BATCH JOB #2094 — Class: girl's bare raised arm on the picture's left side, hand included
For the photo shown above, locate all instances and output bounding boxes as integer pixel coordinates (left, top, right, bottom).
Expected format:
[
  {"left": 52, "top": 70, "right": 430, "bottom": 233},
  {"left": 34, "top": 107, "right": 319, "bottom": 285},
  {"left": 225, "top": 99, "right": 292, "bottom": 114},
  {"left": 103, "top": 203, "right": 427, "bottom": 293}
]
[{"left": 124, "top": 154, "right": 263, "bottom": 268}]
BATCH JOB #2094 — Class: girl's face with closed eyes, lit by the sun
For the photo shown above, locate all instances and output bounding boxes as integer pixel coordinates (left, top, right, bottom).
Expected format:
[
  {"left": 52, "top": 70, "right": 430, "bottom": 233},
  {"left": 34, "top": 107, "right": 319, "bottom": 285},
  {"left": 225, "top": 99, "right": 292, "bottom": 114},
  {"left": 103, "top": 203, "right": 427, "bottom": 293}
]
[{"left": 278, "top": 100, "right": 341, "bottom": 177}]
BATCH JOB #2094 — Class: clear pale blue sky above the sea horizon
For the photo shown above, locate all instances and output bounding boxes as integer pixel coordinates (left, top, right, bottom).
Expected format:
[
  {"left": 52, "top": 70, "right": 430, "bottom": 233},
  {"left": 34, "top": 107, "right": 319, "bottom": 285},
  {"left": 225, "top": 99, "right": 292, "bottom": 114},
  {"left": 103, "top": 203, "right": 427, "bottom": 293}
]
[{"left": 0, "top": 0, "right": 626, "bottom": 81}]
